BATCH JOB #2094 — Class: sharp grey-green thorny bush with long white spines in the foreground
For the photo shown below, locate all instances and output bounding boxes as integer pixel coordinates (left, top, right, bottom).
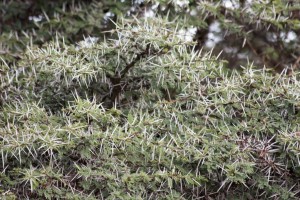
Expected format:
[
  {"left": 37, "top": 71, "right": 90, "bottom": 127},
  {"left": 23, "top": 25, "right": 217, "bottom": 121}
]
[{"left": 0, "top": 18, "right": 300, "bottom": 199}]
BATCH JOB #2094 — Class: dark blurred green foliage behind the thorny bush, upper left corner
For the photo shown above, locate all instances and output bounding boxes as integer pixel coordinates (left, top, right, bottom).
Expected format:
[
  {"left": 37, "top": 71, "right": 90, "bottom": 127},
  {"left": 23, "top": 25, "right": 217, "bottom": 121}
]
[{"left": 0, "top": 0, "right": 113, "bottom": 65}]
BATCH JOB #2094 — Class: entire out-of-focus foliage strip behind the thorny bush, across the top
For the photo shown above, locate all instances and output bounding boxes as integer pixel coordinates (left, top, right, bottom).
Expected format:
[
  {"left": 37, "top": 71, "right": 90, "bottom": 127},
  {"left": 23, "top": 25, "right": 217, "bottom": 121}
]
[{"left": 0, "top": 0, "right": 300, "bottom": 72}]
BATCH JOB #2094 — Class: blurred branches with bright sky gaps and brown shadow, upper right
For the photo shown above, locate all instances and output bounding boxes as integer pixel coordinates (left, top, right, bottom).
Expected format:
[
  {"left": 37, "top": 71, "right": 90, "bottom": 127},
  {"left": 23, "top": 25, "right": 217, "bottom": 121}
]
[{"left": 151, "top": 0, "right": 300, "bottom": 71}]
